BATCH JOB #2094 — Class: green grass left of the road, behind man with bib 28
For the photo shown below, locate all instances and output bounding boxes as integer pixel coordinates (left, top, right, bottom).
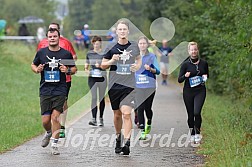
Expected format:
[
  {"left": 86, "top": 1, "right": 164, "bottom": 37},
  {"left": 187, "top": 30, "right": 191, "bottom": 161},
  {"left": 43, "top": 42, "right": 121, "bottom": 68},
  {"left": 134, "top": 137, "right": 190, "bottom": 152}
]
[{"left": 0, "top": 42, "right": 89, "bottom": 153}]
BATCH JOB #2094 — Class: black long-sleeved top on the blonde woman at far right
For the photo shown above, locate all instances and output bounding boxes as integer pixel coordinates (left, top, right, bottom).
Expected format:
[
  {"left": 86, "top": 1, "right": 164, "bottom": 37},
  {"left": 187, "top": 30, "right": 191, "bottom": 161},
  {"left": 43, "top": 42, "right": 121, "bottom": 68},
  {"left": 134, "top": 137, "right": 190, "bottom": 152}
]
[{"left": 178, "top": 59, "right": 209, "bottom": 88}]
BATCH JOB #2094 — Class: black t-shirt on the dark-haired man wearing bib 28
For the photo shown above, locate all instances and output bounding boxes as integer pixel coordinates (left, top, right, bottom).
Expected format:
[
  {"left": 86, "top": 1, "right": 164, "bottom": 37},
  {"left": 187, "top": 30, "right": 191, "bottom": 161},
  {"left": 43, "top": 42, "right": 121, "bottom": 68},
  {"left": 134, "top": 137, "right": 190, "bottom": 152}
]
[{"left": 33, "top": 47, "right": 75, "bottom": 96}]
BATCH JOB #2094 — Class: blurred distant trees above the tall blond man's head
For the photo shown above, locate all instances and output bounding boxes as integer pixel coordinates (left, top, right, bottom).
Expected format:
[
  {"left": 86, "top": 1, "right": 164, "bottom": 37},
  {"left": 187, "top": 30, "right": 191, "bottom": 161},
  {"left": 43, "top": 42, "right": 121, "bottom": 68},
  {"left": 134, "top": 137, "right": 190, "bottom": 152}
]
[{"left": 65, "top": 0, "right": 150, "bottom": 36}]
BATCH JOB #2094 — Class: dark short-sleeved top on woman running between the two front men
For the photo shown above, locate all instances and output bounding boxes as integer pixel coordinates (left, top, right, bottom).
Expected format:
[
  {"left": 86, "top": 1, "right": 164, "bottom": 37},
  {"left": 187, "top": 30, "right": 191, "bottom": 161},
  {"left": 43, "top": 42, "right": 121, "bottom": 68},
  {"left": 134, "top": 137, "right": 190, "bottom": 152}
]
[{"left": 86, "top": 51, "right": 106, "bottom": 77}]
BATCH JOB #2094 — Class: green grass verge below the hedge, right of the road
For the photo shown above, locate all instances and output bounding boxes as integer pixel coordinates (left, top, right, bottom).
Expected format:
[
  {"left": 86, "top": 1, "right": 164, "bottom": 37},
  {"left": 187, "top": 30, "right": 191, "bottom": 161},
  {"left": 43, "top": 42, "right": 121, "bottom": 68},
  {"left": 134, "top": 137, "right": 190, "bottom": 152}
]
[{"left": 198, "top": 93, "right": 252, "bottom": 167}]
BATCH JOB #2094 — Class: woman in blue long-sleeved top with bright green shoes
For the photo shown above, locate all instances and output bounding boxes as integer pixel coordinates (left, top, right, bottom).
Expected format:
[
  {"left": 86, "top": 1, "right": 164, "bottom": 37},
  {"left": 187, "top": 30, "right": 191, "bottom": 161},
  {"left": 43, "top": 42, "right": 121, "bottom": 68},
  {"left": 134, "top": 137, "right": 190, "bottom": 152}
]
[{"left": 135, "top": 37, "right": 160, "bottom": 140}]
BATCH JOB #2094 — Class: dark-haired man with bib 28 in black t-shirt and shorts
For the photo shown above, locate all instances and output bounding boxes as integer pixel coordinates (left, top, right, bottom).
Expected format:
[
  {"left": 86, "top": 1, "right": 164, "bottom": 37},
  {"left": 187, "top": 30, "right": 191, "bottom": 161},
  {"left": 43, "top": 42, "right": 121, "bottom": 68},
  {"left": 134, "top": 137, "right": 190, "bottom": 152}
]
[{"left": 31, "top": 29, "right": 77, "bottom": 155}]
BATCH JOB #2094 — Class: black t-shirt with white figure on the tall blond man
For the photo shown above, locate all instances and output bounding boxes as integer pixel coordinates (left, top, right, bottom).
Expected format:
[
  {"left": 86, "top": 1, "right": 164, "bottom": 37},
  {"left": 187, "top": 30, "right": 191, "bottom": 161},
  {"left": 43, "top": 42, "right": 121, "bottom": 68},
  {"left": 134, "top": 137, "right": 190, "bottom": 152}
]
[{"left": 104, "top": 41, "right": 140, "bottom": 89}]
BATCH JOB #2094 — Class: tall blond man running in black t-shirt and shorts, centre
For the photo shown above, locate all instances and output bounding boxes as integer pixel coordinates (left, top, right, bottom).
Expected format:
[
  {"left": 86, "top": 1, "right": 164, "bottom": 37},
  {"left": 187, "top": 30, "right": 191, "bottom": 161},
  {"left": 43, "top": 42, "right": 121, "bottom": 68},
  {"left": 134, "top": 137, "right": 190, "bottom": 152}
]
[{"left": 101, "top": 20, "right": 141, "bottom": 155}]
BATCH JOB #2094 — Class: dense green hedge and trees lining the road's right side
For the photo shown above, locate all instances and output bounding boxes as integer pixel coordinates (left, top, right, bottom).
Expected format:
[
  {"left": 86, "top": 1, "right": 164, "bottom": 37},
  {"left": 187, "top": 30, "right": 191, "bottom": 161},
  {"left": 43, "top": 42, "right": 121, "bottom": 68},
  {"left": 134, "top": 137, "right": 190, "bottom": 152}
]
[{"left": 147, "top": 0, "right": 252, "bottom": 104}]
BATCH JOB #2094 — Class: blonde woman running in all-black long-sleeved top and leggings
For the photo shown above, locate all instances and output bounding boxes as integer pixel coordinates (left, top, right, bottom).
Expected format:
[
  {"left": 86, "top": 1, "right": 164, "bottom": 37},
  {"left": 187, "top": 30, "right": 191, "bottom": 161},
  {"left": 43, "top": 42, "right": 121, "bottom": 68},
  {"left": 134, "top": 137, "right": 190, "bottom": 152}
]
[{"left": 178, "top": 42, "right": 209, "bottom": 143}]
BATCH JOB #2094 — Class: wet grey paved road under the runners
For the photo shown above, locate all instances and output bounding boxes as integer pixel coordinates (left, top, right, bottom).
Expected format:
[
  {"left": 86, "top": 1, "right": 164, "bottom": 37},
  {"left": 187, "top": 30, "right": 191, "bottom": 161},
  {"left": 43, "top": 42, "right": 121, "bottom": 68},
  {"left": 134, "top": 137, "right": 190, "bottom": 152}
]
[{"left": 0, "top": 79, "right": 203, "bottom": 167}]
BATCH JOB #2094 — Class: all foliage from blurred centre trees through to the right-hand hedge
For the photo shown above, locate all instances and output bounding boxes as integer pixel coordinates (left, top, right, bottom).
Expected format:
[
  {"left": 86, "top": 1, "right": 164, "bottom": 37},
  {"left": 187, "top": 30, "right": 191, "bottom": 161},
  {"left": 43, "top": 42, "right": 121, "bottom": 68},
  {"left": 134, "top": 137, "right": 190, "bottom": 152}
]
[{"left": 66, "top": 0, "right": 252, "bottom": 104}]
